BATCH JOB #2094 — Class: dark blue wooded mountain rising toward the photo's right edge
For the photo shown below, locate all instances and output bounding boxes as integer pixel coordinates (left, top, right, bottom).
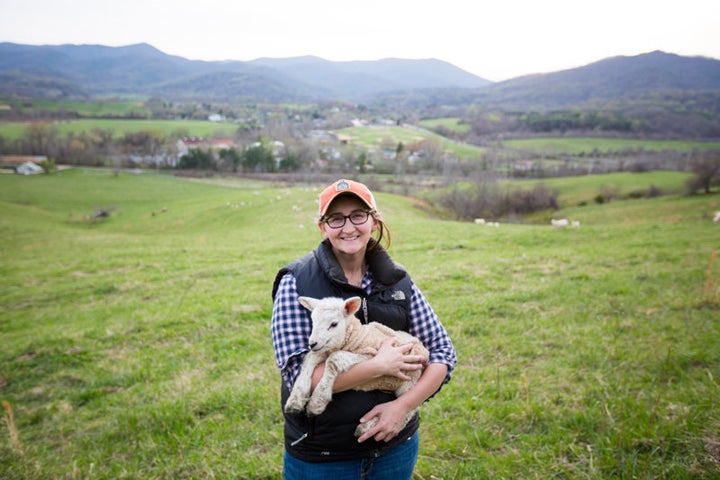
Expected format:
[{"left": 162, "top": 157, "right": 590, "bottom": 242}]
[{"left": 374, "top": 51, "right": 720, "bottom": 113}]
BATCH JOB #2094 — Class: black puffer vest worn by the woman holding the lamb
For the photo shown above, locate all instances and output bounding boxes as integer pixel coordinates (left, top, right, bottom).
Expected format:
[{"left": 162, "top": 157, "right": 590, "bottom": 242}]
[{"left": 272, "top": 240, "right": 419, "bottom": 462}]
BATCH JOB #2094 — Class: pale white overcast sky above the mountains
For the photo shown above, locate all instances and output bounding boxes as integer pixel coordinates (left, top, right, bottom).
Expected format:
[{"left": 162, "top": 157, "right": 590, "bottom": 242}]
[{"left": 0, "top": 0, "right": 720, "bottom": 81}]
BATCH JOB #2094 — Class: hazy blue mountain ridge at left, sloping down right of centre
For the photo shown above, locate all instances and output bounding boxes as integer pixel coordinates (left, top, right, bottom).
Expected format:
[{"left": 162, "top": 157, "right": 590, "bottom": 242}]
[{"left": 0, "top": 43, "right": 490, "bottom": 102}]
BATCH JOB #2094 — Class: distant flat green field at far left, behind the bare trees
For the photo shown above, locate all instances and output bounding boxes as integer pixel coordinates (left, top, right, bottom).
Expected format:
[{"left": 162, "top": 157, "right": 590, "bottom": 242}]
[{"left": 0, "top": 118, "right": 237, "bottom": 141}]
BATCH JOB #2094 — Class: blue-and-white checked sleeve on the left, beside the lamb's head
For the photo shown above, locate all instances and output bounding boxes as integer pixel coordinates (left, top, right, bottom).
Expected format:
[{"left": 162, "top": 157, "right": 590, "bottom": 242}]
[{"left": 270, "top": 273, "right": 312, "bottom": 388}]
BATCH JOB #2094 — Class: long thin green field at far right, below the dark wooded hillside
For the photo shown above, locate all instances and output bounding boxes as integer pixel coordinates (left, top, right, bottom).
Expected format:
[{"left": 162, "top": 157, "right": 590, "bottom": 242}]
[{"left": 503, "top": 137, "right": 720, "bottom": 155}]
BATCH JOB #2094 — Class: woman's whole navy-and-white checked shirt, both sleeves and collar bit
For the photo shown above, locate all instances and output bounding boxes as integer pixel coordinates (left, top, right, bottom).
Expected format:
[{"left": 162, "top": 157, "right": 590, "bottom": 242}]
[{"left": 271, "top": 272, "right": 457, "bottom": 388}]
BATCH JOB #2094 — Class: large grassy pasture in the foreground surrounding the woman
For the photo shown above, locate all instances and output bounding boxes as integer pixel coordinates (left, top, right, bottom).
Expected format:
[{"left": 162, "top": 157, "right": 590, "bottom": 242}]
[{"left": 0, "top": 170, "right": 720, "bottom": 480}]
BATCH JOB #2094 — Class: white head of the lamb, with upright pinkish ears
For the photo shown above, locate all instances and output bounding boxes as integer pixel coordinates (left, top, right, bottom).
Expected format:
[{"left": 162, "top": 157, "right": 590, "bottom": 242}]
[{"left": 299, "top": 297, "right": 362, "bottom": 352}]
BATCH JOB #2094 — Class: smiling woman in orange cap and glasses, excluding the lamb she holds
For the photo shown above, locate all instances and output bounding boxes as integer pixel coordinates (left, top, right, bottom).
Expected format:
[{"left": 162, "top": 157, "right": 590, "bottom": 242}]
[{"left": 271, "top": 180, "right": 456, "bottom": 480}]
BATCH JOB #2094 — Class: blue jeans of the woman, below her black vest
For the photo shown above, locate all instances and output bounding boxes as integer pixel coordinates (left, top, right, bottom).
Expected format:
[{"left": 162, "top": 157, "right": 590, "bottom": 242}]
[{"left": 283, "top": 432, "right": 420, "bottom": 480}]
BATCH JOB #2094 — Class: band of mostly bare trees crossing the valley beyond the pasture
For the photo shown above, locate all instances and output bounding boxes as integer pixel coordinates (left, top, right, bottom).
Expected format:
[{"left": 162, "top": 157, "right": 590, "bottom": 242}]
[{"left": 0, "top": 120, "right": 720, "bottom": 195}]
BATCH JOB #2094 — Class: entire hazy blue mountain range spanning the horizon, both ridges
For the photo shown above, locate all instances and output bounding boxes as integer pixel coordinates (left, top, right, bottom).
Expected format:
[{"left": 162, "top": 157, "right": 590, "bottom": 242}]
[{"left": 0, "top": 43, "right": 720, "bottom": 110}]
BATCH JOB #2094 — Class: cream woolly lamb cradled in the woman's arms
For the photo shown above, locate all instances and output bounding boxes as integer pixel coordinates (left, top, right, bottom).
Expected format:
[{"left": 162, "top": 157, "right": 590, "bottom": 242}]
[{"left": 285, "top": 297, "right": 430, "bottom": 437}]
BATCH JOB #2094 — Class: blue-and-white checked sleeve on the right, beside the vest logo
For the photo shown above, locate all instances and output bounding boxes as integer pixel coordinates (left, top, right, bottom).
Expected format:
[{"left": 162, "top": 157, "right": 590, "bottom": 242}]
[{"left": 410, "top": 282, "right": 457, "bottom": 384}]
